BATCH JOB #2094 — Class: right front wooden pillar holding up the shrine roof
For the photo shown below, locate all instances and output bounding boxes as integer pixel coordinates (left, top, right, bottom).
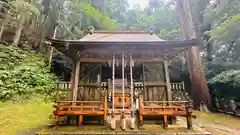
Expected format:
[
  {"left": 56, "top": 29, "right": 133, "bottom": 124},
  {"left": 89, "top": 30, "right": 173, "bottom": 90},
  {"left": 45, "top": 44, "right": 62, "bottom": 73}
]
[{"left": 164, "top": 59, "right": 172, "bottom": 101}]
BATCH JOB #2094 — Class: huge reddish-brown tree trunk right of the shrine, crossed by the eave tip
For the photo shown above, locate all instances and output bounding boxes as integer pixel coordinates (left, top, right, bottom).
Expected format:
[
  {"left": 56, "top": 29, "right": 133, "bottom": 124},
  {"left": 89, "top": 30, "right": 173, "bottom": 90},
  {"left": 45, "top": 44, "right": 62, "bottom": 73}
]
[{"left": 177, "top": 0, "right": 211, "bottom": 108}]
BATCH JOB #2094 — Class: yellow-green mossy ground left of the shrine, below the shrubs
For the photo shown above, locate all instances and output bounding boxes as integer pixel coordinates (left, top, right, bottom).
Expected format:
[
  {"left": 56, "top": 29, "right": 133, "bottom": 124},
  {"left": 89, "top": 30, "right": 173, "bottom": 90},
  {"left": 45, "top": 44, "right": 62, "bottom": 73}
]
[{"left": 0, "top": 99, "right": 52, "bottom": 135}]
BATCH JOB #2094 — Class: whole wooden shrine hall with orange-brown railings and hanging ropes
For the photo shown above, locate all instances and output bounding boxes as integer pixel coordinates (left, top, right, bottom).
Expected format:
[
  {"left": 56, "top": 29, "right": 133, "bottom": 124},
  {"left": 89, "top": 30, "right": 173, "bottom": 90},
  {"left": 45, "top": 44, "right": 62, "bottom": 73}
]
[{"left": 48, "top": 29, "right": 198, "bottom": 129}]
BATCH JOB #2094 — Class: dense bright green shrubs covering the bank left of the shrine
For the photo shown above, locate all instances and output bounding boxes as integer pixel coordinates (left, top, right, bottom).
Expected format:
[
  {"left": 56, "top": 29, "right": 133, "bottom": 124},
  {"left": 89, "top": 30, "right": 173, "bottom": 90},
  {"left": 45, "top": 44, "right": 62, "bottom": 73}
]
[{"left": 0, "top": 45, "right": 56, "bottom": 99}]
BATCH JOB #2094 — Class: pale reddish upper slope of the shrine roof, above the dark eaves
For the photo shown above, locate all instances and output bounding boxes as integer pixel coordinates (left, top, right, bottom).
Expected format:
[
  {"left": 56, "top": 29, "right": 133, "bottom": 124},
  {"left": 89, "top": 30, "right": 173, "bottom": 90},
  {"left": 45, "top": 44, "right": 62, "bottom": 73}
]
[{"left": 79, "top": 30, "right": 163, "bottom": 42}]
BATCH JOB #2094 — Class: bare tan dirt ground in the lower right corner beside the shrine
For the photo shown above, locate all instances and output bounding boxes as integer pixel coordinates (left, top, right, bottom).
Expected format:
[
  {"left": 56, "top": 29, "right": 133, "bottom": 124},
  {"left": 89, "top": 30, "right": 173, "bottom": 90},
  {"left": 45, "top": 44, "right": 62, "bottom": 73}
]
[{"left": 194, "top": 111, "right": 240, "bottom": 135}]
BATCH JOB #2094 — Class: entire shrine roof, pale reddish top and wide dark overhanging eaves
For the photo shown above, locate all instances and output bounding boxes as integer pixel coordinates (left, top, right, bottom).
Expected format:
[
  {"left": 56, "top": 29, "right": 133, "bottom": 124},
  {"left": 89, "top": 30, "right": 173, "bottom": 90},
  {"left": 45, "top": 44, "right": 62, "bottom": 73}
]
[{"left": 47, "top": 30, "right": 199, "bottom": 58}]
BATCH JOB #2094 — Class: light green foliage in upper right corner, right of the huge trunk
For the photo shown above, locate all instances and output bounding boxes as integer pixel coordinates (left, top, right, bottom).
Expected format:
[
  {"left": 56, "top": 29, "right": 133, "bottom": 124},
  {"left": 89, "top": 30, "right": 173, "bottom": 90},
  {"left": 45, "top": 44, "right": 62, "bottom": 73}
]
[{"left": 203, "top": 0, "right": 240, "bottom": 63}]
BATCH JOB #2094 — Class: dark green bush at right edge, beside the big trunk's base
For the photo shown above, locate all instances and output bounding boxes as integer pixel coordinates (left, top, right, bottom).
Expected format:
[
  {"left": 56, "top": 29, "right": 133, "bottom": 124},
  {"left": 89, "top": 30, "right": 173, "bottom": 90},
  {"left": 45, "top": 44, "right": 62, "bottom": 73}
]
[{"left": 207, "top": 63, "right": 240, "bottom": 101}]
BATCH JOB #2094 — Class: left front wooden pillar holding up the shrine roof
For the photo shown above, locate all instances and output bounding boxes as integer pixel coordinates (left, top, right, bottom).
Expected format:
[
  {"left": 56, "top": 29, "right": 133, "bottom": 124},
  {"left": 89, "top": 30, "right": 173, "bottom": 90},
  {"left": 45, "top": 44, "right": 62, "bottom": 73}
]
[{"left": 72, "top": 59, "right": 80, "bottom": 105}]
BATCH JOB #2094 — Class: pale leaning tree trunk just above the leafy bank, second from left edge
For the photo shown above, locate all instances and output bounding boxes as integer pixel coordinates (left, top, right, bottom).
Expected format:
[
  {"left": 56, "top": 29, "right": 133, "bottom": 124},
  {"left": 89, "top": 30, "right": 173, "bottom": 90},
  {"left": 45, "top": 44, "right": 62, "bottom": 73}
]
[{"left": 12, "top": 16, "right": 25, "bottom": 46}]
